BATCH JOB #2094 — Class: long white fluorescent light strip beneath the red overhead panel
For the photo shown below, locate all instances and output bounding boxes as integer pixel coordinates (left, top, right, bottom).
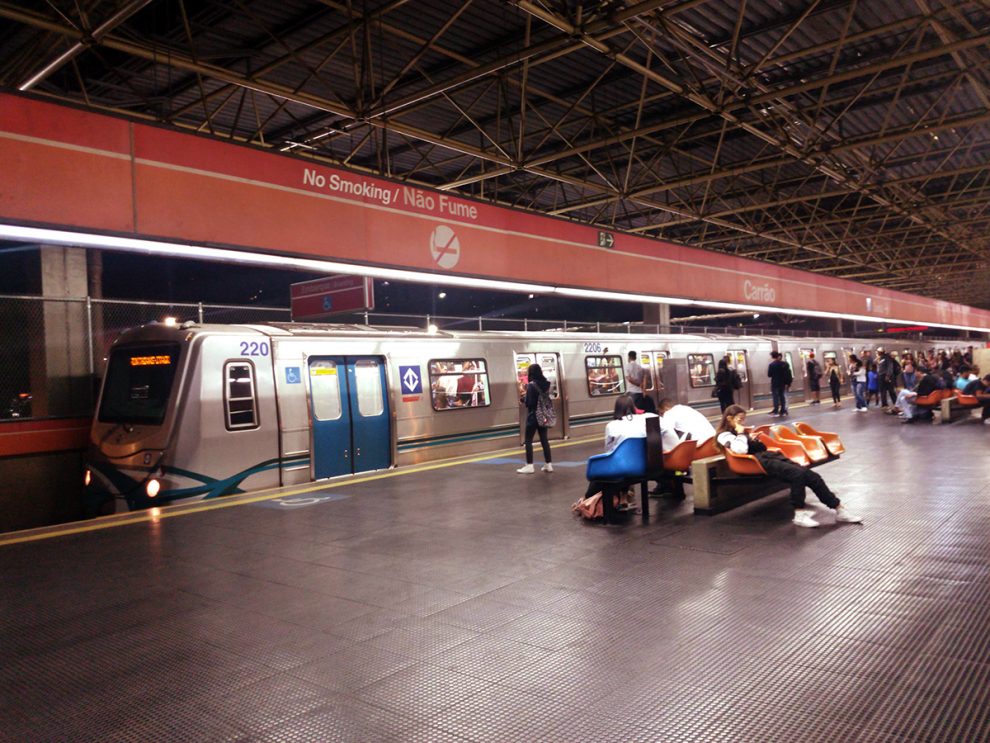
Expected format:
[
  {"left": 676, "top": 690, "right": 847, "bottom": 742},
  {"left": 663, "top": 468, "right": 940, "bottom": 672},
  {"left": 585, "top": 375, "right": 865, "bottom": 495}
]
[{"left": 0, "top": 224, "right": 990, "bottom": 333}]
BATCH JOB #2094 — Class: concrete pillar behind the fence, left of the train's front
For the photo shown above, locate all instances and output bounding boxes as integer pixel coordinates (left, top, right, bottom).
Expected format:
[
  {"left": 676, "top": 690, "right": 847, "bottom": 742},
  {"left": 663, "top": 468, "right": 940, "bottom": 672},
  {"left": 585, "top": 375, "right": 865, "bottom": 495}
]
[{"left": 30, "top": 245, "right": 92, "bottom": 418}]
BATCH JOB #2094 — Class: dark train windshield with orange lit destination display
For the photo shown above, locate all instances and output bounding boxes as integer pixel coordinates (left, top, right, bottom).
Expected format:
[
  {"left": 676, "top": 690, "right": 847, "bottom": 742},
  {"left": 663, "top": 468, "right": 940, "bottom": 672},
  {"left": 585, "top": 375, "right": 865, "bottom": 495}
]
[{"left": 99, "top": 343, "right": 179, "bottom": 426}]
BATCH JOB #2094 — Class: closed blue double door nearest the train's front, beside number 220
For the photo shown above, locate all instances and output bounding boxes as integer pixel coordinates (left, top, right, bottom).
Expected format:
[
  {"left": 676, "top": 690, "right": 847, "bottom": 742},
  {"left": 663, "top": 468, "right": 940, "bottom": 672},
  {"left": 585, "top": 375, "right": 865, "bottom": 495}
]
[{"left": 309, "top": 356, "right": 392, "bottom": 480}]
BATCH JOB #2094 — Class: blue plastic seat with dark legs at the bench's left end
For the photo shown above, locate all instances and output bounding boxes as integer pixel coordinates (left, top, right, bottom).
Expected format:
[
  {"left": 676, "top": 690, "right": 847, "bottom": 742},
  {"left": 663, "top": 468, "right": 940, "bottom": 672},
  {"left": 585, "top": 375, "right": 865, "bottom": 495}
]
[{"left": 585, "top": 418, "right": 663, "bottom": 524}]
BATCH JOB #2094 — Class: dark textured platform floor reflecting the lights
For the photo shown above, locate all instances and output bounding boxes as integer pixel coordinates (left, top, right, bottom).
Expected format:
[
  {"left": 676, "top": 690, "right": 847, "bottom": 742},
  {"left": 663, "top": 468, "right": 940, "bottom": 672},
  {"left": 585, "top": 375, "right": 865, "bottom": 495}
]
[{"left": 0, "top": 403, "right": 990, "bottom": 743}]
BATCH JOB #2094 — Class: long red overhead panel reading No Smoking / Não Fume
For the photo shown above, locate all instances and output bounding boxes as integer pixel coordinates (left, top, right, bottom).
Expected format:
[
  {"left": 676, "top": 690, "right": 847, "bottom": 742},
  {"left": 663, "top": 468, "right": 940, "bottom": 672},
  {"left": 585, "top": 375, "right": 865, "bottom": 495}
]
[{"left": 0, "top": 94, "right": 990, "bottom": 328}]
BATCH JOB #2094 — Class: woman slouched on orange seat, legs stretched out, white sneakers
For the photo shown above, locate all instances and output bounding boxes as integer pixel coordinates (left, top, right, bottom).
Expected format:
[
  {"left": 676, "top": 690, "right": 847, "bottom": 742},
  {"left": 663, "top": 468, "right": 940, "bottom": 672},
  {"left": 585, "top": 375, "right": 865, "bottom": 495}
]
[{"left": 715, "top": 405, "right": 863, "bottom": 527}]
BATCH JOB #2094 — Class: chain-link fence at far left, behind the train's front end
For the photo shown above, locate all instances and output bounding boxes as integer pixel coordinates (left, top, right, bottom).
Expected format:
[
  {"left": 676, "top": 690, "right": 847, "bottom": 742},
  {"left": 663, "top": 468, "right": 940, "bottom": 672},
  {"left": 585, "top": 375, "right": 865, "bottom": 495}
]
[{"left": 0, "top": 295, "right": 290, "bottom": 419}]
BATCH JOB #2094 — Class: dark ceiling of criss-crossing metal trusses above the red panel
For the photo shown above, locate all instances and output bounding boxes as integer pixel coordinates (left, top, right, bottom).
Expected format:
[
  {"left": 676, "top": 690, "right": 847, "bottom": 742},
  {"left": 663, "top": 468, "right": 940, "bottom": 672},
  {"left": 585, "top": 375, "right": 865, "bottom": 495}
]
[{"left": 0, "top": 0, "right": 990, "bottom": 308}]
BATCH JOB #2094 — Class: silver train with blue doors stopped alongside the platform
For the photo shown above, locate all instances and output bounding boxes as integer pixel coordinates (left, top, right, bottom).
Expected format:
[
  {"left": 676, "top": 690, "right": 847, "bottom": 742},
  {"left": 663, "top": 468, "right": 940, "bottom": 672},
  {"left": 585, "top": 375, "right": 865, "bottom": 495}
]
[{"left": 85, "top": 323, "right": 921, "bottom": 514}]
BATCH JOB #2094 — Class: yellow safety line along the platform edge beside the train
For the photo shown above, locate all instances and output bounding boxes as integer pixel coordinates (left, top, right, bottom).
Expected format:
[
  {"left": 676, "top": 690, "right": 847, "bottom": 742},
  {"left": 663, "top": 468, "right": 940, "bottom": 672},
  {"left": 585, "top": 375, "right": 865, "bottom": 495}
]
[{"left": 0, "top": 435, "right": 601, "bottom": 547}]
